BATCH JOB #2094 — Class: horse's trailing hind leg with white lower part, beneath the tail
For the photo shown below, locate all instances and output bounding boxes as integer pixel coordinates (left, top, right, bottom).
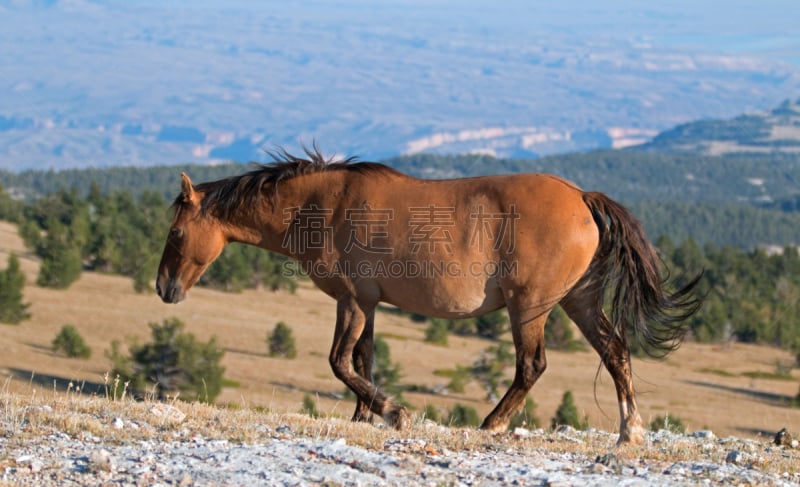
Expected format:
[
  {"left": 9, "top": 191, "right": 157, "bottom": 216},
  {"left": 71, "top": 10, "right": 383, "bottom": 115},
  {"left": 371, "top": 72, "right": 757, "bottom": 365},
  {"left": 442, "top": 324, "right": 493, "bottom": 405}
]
[{"left": 560, "top": 282, "right": 644, "bottom": 444}]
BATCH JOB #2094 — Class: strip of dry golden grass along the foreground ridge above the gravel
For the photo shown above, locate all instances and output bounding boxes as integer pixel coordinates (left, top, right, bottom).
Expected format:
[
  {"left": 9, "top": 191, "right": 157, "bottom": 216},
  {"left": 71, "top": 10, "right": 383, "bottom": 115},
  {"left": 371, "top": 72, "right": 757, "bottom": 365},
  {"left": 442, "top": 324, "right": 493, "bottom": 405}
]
[{"left": 0, "top": 390, "right": 800, "bottom": 476}]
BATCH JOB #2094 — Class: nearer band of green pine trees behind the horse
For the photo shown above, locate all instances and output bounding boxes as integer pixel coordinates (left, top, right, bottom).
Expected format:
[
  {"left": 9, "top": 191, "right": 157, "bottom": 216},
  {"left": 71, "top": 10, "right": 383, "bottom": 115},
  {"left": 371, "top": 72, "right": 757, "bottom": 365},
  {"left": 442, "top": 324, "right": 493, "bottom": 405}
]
[{"left": 0, "top": 184, "right": 800, "bottom": 351}]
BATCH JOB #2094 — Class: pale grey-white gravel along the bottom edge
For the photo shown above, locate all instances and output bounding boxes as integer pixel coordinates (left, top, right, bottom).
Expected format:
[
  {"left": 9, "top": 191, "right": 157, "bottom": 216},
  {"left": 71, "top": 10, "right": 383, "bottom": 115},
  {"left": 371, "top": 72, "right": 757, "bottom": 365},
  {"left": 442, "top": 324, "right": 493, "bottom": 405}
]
[{"left": 0, "top": 426, "right": 800, "bottom": 486}]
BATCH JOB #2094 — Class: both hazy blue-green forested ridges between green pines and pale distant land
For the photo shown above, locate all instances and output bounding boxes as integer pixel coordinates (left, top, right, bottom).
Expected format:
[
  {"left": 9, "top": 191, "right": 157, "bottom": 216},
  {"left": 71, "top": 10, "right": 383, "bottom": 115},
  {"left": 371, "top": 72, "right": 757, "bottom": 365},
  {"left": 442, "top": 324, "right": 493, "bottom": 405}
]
[{"left": 0, "top": 150, "right": 800, "bottom": 249}]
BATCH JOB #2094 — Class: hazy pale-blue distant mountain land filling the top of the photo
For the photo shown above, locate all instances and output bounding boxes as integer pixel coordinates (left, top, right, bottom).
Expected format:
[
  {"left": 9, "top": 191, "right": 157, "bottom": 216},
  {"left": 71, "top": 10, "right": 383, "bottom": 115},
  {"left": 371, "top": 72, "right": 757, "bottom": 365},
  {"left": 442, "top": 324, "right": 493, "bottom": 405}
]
[{"left": 0, "top": 0, "right": 800, "bottom": 172}]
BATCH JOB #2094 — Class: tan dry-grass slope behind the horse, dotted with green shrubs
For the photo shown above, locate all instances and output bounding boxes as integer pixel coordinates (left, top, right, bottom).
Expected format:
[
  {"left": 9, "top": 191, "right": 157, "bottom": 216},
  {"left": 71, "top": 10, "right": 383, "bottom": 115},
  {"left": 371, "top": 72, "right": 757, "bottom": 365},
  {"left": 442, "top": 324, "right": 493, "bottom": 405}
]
[{"left": 0, "top": 222, "right": 800, "bottom": 444}]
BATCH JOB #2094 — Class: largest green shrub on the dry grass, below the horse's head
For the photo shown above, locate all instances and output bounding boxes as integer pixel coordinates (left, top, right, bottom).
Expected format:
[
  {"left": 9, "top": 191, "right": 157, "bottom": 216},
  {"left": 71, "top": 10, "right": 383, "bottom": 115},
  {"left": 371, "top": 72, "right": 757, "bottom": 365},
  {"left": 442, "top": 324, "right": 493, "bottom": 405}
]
[{"left": 109, "top": 318, "right": 225, "bottom": 402}]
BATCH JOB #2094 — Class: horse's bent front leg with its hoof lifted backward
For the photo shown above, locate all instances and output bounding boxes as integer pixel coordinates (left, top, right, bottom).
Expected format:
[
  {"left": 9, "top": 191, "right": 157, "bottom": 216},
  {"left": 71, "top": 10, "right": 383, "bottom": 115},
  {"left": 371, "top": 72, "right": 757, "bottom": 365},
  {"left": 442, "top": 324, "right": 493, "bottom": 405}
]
[{"left": 329, "top": 296, "right": 409, "bottom": 429}]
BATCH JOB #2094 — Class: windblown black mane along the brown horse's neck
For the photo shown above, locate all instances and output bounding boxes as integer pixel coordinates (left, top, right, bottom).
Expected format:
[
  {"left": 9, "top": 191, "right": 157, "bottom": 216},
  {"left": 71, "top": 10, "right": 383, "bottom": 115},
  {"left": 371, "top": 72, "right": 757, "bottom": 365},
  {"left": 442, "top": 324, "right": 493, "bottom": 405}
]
[{"left": 175, "top": 145, "right": 395, "bottom": 218}]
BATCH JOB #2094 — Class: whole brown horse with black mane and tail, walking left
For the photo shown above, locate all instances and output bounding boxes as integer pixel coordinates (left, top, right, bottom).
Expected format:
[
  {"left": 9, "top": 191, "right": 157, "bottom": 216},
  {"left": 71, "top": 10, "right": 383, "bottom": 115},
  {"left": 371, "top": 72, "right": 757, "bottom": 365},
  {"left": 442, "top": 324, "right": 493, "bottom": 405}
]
[{"left": 156, "top": 148, "right": 699, "bottom": 443}]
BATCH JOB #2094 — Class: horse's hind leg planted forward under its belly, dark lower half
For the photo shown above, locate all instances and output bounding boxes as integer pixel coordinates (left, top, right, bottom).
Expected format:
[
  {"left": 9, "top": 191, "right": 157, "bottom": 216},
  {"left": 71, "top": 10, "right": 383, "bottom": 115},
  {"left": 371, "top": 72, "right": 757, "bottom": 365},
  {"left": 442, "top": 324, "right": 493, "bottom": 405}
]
[{"left": 481, "top": 306, "right": 547, "bottom": 431}]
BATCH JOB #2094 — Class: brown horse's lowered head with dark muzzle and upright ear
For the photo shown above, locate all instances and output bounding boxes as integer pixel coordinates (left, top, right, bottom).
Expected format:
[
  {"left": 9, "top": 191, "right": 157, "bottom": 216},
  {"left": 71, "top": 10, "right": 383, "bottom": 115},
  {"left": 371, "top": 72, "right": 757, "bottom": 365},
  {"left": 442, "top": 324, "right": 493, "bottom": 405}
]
[{"left": 156, "top": 173, "right": 227, "bottom": 303}]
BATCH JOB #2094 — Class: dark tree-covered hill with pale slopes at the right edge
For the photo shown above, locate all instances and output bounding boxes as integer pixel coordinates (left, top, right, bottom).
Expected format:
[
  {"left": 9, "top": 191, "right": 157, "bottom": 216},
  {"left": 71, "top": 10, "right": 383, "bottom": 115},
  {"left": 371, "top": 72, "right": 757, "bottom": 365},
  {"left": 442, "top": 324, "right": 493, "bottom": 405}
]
[{"left": 637, "top": 98, "right": 800, "bottom": 155}]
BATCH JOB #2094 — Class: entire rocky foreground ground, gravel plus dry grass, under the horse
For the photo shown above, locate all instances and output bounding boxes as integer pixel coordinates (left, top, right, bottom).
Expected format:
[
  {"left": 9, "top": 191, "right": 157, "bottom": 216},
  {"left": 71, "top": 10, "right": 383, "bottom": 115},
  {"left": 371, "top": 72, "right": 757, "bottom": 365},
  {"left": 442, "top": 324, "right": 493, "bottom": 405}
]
[{"left": 0, "top": 405, "right": 800, "bottom": 486}]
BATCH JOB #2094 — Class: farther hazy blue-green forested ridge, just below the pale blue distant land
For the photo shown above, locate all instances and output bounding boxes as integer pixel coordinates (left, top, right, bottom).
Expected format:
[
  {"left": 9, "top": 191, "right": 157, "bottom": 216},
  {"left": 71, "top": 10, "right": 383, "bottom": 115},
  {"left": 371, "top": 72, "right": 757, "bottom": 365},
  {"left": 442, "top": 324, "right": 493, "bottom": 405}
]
[{"left": 6, "top": 147, "right": 800, "bottom": 206}]
